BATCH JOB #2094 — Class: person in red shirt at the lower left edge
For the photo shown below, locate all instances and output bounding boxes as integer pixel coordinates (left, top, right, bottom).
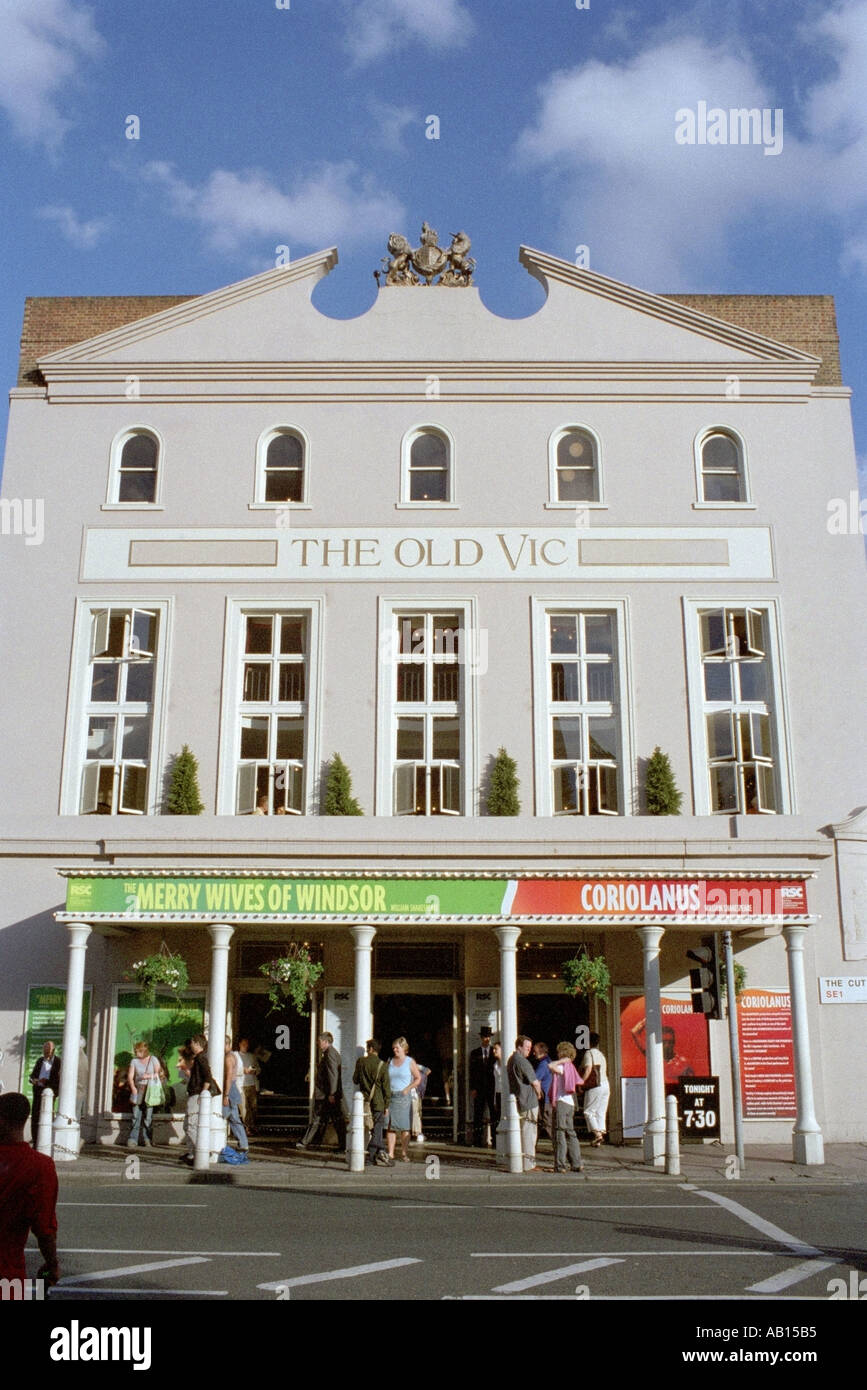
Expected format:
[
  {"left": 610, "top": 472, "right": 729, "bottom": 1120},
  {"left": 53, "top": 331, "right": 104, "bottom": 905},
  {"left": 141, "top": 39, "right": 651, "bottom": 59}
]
[{"left": 0, "top": 1091, "right": 60, "bottom": 1284}]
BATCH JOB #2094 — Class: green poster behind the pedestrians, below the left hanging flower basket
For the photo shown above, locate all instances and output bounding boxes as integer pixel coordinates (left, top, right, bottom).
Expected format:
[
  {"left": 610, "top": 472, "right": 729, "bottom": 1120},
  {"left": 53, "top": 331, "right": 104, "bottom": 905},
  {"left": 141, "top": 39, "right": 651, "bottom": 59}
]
[{"left": 111, "top": 990, "right": 207, "bottom": 1113}]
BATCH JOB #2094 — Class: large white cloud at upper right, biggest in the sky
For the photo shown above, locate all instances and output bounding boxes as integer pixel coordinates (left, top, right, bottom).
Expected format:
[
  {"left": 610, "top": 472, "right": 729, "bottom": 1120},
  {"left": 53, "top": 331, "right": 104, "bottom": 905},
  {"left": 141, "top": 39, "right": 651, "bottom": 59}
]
[{"left": 517, "top": 0, "right": 867, "bottom": 292}]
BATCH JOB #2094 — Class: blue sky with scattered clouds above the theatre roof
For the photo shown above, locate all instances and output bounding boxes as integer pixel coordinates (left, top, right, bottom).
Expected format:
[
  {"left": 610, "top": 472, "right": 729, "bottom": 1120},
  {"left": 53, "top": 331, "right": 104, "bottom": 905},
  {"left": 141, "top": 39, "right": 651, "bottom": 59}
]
[{"left": 0, "top": 0, "right": 867, "bottom": 500}]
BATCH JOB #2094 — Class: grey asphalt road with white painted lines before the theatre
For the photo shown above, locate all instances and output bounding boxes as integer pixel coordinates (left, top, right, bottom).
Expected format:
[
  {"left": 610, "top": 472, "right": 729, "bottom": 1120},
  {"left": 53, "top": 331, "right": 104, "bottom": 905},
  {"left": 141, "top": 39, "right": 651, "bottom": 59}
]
[{"left": 28, "top": 1172, "right": 867, "bottom": 1311}]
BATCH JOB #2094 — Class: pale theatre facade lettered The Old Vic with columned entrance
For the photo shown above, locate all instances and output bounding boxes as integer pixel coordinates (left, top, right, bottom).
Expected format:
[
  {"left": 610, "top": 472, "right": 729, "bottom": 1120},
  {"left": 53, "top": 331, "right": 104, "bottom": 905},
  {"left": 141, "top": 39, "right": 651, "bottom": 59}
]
[{"left": 0, "top": 241, "right": 867, "bottom": 1162}]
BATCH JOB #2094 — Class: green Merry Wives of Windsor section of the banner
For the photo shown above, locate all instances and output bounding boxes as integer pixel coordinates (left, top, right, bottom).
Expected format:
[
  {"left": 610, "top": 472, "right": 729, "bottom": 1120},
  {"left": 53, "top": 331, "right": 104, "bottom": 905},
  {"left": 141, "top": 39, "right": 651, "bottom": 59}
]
[{"left": 67, "top": 874, "right": 509, "bottom": 917}]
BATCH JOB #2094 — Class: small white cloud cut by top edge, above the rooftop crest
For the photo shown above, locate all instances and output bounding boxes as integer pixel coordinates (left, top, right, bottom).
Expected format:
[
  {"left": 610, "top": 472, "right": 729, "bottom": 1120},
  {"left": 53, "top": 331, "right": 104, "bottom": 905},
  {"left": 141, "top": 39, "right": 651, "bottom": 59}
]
[{"left": 343, "top": 0, "right": 475, "bottom": 65}]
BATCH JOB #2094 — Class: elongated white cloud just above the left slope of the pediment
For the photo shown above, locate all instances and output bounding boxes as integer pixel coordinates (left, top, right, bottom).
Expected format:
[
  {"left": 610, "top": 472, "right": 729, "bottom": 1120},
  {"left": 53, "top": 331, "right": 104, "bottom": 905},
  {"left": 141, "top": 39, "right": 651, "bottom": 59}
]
[{"left": 143, "top": 161, "right": 404, "bottom": 257}]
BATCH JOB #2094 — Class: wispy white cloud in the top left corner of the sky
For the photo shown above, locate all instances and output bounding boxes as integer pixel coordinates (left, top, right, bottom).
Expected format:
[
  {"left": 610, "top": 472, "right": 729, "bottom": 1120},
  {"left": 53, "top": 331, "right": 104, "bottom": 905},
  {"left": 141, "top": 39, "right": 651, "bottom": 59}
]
[{"left": 0, "top": 0, "right": 106, "bottom": 149}]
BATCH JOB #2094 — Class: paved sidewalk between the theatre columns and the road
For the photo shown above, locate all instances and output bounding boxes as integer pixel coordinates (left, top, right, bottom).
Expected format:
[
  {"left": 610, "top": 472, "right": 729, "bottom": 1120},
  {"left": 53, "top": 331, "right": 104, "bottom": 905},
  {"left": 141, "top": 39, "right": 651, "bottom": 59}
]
[{"left": 57, "top": 1140, "right": 867, "bottom": 1190}]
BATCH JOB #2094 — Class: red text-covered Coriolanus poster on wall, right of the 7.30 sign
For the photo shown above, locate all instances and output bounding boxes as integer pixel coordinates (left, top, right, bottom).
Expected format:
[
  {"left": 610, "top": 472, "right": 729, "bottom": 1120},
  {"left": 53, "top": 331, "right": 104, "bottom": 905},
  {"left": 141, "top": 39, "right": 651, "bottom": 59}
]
[{"left": 738, "top": 990, "right": 796, "bottom": 1120}]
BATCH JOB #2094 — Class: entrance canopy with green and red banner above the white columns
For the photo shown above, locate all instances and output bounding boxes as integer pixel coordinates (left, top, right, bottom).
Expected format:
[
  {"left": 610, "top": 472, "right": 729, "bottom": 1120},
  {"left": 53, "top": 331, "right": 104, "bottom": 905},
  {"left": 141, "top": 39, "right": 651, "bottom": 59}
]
[{"left": 56, "top": 869, "right": 814, "bottom": 930}]
